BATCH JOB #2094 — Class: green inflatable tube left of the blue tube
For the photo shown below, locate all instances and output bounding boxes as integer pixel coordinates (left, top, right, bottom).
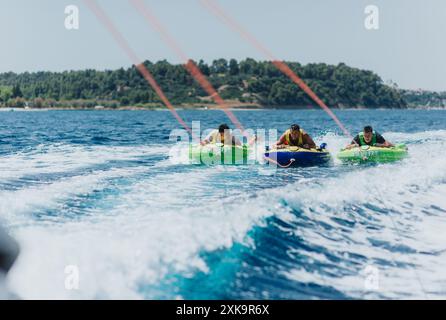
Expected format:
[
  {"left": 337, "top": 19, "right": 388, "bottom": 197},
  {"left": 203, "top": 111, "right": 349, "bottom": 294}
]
[{"left": 189, "top": 143, "right": 249, "bottom": 165}]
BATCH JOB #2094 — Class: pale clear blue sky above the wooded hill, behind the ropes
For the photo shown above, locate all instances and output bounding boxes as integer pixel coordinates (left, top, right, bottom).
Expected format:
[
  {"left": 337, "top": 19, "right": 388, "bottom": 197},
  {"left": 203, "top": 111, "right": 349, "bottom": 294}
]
[{"left": 0, "top": 0, "right": 446, "bottom": 91}]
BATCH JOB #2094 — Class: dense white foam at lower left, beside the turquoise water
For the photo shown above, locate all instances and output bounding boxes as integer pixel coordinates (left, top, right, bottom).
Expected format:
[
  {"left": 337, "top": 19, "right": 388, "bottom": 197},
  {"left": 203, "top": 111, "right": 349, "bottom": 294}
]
[{"left": 6, "top": 173, "right": 268, "bottom": 299}]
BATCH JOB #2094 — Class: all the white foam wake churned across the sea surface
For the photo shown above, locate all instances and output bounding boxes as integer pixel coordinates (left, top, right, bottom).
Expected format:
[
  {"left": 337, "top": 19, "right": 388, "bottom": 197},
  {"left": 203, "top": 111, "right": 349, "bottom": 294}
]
[{"left": 0, "top": 131, "right": 446, "bottom": 299}]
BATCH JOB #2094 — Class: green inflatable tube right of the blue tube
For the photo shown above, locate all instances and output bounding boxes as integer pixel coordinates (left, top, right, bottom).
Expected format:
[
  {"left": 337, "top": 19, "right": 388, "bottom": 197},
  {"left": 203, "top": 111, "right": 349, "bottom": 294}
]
[{"left": 337, "top": 144, "right": 408, "bottom": 163}]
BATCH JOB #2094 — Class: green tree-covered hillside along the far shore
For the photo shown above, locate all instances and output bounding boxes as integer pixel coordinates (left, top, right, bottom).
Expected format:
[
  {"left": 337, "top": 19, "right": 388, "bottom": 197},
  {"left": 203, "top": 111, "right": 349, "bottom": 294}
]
[{"left": 0, "top": 58, "right": 446, "bottom": 109}]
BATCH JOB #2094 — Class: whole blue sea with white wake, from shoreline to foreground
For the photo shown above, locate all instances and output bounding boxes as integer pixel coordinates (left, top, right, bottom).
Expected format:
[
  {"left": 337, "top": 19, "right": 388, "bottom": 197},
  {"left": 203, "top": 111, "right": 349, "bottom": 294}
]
[{"left": 0, "top": 110, "right": 446, "bottom": 299}]
